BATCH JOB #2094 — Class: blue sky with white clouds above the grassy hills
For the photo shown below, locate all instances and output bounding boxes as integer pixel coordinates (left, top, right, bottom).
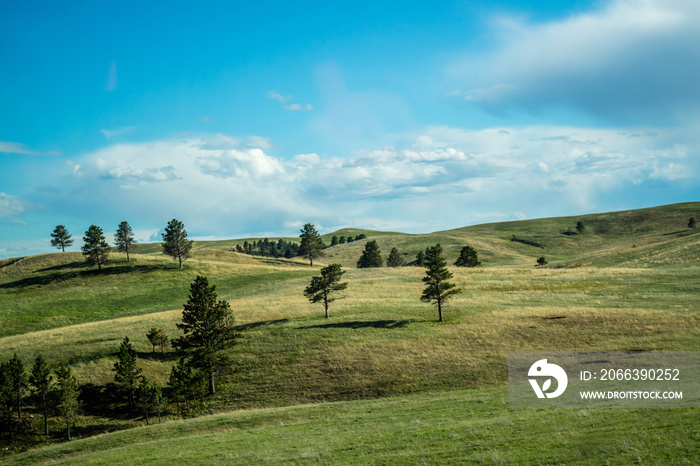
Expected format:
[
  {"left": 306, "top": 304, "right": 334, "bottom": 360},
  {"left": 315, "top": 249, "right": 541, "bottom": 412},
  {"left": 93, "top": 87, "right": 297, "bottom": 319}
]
[{"left": 0, "top": 0, "right": 700, "bottom": 258}]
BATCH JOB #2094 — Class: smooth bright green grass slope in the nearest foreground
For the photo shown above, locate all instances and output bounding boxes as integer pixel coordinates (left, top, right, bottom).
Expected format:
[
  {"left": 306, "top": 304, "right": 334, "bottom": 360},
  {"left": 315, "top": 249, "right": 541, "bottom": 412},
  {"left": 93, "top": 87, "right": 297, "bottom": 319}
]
[{"left": 7, "top": 388, "right": 700, "bottom": 464}]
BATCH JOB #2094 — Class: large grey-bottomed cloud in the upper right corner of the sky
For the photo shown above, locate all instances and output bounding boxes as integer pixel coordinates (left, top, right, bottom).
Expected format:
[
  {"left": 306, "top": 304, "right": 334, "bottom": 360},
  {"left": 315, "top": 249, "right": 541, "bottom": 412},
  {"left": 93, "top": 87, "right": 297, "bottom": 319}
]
[{"left": 451, "top": 0, "right": 700, "bottom": 121}]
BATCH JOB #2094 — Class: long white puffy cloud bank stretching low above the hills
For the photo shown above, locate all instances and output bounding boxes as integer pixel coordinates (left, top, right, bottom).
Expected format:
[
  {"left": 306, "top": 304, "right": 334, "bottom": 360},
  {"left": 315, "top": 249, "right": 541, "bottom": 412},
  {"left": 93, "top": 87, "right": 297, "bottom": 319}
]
[{"left": 60, "top": 126, "right": 698, "bottom": 236}]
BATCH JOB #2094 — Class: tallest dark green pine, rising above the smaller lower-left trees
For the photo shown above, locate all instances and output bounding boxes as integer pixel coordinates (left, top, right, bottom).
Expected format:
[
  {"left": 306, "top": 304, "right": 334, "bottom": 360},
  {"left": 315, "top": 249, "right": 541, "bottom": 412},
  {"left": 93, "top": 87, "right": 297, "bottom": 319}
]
[{"left": 172, "top": 276, "right": 238, "bottom": 395}]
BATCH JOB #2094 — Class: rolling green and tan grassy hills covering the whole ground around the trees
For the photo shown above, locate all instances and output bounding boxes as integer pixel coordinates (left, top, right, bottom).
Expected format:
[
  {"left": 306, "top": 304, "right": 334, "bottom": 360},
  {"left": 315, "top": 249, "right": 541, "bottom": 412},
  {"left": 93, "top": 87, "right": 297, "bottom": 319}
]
[{"left": 0, "top": 203, "right": 700, "bottom": 463}]
